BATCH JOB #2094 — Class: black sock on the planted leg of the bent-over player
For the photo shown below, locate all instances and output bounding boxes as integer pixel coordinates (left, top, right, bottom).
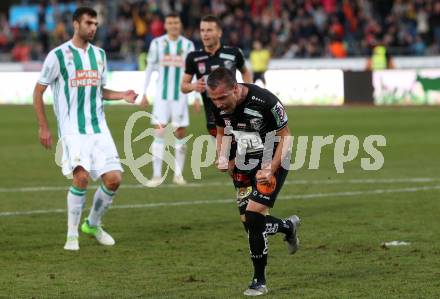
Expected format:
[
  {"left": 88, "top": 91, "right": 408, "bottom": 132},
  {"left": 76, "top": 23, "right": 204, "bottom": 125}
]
[{"left": 245, "top": 211, "right": 268, "bottom": 282}]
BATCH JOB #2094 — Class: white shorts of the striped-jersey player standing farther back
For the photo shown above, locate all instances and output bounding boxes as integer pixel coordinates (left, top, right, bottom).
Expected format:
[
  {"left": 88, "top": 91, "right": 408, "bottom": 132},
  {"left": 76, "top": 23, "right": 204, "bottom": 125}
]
[{"left": 151, "top": 98, "right": 189, "bottom": 128}]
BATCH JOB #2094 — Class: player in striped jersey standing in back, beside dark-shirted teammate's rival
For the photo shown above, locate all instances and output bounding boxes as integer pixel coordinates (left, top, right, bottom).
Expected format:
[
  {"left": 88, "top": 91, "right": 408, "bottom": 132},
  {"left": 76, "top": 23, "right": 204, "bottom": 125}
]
[{"left": 141, "top": 13, "right": 198, "bottom": 187}]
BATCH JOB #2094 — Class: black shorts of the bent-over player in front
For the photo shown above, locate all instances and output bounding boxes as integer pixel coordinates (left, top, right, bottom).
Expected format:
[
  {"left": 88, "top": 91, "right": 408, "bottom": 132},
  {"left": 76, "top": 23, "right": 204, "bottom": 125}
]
[{"left": 233, "top": 167, "right": 289, "bottom": 215}]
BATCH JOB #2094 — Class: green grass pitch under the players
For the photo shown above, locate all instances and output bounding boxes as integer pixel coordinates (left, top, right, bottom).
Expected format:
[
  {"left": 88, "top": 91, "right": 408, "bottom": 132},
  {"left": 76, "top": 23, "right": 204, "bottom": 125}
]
[{"left": 0, "top": 106, "right": 440, "bottom": 299}]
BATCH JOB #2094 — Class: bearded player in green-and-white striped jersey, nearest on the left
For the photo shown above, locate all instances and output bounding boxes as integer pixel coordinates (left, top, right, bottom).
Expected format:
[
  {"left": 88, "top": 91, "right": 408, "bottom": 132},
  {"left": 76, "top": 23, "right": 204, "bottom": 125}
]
[{"left": 34, "top": 7, "right": 137, "bottom": 250}]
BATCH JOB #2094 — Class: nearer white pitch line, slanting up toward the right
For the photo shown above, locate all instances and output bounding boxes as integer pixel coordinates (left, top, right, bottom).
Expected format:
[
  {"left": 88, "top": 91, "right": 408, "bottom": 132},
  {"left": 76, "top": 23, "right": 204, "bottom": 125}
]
[{"left": 0, "top": 185, "right": 440, "bottom": 217}]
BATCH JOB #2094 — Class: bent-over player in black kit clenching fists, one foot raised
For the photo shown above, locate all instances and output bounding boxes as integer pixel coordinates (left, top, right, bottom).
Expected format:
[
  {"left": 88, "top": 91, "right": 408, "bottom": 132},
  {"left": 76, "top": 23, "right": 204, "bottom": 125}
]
[{"left": 207, "top": 68, "right": 300, "bottom": 296}]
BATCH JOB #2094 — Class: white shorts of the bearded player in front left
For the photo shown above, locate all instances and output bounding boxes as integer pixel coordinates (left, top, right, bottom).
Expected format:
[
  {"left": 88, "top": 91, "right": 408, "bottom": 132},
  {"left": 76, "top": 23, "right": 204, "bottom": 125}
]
[{"left": 60, "top": 132, "right": 123, "bottom": 181}]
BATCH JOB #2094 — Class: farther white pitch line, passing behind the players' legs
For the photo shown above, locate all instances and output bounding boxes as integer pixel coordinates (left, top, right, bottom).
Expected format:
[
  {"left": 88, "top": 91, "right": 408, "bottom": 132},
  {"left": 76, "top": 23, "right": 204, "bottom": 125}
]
[{"left": 0, "top": 178, "right": 440, "bottom": 193}]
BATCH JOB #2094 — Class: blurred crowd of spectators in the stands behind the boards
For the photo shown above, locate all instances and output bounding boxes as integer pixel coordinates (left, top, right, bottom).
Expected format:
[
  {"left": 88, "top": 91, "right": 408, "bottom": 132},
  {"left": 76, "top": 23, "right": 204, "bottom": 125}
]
[{"left": 0, "top": 0, "right": 440, "bottom": 62}]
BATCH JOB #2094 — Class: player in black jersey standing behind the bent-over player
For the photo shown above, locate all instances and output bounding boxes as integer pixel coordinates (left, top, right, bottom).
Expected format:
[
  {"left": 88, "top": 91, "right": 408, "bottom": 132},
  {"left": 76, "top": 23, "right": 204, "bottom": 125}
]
[{"left": 181, "top": 15, "right": 252, "bottom": 137}]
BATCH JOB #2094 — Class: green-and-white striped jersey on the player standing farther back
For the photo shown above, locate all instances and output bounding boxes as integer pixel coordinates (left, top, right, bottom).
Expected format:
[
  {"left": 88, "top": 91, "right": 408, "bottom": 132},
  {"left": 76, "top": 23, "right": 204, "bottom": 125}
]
[{"left": 144, "top": 34, "right": 194, "bottom": 101}]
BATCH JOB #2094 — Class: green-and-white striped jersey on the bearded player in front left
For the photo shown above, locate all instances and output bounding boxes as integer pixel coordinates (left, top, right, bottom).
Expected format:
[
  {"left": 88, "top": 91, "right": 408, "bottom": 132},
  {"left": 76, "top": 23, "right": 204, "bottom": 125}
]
[{"left": 38, "top": 41, "right": 108, "bottom": 137}]
